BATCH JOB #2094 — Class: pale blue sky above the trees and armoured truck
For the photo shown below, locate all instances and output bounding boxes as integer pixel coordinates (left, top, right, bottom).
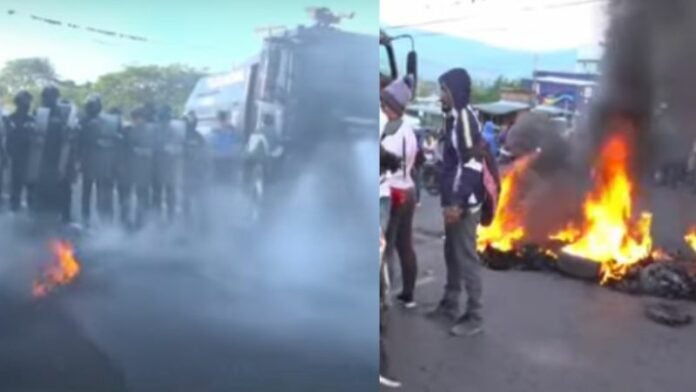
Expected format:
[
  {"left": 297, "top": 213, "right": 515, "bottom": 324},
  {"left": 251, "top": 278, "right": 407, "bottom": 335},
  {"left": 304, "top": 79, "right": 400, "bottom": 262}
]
[{"left": 0, "top": 0, "right": 379, "bottom": 82}]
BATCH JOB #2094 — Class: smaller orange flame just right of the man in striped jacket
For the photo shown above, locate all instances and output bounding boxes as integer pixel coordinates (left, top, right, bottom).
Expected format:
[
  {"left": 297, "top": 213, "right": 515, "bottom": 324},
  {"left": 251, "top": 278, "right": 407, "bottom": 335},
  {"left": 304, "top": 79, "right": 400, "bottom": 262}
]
[{"left": 476, "top": 155, "right": 536, "bottom": 252}]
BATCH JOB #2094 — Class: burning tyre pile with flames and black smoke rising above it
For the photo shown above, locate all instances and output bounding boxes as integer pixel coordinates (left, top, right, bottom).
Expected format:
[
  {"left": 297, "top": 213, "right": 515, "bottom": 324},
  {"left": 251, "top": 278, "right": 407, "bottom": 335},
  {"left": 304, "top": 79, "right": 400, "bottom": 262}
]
[{"left": 478, "top": 0, "right": 696, "bottom": 299}]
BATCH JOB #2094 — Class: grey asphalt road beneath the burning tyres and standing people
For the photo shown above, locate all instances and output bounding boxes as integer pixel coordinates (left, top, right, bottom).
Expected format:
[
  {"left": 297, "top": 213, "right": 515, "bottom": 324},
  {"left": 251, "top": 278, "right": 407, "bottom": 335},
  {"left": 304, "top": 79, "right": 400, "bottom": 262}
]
[{"left": 384, "top": 191, "right": 696, "bottom": 392}]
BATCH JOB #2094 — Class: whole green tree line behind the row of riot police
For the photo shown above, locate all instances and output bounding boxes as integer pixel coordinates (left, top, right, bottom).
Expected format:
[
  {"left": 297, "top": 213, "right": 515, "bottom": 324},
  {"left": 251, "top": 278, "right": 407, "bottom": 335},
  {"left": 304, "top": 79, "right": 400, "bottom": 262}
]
[{"left": 0, "top": 58, "right": 205, "bottom": 113}]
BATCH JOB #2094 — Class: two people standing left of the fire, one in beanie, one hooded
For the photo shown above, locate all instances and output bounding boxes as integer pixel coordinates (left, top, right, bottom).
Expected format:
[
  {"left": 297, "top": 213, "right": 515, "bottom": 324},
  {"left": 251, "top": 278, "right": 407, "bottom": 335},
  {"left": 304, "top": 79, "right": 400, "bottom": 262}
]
[{"left": 380, "top": 68, "right": 500, "bottom": 388}]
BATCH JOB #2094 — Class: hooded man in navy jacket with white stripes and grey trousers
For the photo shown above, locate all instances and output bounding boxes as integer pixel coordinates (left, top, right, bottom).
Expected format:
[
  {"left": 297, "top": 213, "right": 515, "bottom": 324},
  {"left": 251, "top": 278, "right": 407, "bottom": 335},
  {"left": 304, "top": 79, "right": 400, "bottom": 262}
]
[{"left": 431, "top": 68, "right": 485, "bottom": 336}]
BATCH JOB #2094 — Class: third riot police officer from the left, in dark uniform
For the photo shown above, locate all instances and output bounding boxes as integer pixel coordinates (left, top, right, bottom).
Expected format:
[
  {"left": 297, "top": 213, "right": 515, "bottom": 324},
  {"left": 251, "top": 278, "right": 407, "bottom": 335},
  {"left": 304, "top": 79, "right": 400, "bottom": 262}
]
[{"left": 78, "top": 94, "right": 121, "bottom": 225}]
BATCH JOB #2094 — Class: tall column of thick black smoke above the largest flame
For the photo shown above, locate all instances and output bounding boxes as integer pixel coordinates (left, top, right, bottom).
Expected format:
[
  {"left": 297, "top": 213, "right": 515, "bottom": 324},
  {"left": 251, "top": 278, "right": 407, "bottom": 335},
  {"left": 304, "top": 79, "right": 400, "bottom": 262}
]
[{"left": 583, "top": 0, "right": 696, "bottom": 177}]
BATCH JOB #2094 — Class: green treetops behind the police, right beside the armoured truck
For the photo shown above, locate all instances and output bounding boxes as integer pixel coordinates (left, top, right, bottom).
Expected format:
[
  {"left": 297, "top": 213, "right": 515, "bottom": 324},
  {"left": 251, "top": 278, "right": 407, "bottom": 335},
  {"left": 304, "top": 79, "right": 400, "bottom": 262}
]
[{"left": 93, "top": 64, "right": 204, "bottom": 113}]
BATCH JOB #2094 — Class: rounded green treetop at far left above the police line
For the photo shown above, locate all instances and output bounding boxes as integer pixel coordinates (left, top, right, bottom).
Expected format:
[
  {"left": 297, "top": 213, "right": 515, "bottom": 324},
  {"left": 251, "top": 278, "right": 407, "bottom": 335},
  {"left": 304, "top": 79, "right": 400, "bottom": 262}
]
[{"left": 0, "top": 57, "right": 58, "bottom": 95}]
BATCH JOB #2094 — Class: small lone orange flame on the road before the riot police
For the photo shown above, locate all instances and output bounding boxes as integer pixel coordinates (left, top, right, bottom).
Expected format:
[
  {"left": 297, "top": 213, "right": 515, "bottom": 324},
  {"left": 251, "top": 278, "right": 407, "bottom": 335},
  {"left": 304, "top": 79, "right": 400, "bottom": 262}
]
[{"left": 32, "top": 241, "right": 80, "bottom": 298}]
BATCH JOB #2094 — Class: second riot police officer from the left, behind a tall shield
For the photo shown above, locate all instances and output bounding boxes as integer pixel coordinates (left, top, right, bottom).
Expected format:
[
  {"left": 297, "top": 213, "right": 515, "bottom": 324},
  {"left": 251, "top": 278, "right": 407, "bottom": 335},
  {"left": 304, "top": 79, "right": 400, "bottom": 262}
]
[{"left": 29, "top": 86, "right": 75, "bottom": 223}]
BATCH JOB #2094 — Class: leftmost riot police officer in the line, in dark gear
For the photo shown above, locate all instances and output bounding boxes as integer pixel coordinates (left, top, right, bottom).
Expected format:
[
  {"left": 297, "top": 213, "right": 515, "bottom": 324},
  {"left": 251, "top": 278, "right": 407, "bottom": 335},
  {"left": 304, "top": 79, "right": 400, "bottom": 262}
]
[{"left": 5, "top": 90, "right": 36, "bottom": 212}]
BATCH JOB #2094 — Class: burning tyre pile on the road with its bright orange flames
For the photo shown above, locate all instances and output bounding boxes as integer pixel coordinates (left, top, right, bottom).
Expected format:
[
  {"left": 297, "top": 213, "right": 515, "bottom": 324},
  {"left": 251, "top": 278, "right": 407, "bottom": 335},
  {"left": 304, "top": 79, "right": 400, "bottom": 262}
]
[{"left": 477, "top": 135, "right": 696, "bottom": 299}]
